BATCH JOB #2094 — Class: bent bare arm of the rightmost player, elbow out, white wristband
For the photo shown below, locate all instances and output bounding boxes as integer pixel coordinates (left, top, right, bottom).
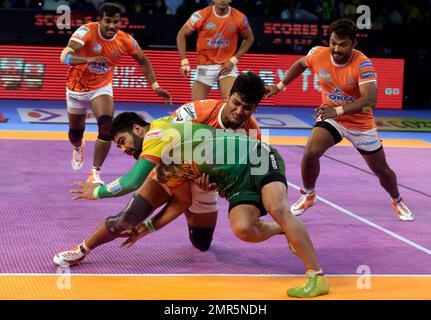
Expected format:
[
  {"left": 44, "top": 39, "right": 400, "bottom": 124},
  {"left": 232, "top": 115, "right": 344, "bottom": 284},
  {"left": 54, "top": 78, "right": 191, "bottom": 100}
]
[{"left": 316, "top": 81, "right": 377, "bottom": 120}]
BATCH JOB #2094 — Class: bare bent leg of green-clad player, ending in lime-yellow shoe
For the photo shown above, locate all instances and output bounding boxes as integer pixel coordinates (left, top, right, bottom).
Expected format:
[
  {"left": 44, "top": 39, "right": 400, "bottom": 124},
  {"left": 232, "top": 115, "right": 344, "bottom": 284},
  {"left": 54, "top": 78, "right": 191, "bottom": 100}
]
[{"left": 261, "top": 181, "right": 329, "bottom": 298}]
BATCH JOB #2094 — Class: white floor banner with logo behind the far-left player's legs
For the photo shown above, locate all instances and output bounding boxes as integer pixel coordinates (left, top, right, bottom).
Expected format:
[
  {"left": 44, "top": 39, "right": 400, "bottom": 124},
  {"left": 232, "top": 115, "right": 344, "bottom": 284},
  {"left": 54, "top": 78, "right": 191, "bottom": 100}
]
[{"left": 17, "top": 108, "right": 154, "bottom": 124}]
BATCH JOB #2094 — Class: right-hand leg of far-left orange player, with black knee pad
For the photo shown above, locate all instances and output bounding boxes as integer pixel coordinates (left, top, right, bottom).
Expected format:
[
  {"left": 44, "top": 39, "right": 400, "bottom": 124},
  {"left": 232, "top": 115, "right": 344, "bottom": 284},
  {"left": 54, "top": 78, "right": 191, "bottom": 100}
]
[{"left": 88, "top": 89, "right": 114, "bottom": 184}]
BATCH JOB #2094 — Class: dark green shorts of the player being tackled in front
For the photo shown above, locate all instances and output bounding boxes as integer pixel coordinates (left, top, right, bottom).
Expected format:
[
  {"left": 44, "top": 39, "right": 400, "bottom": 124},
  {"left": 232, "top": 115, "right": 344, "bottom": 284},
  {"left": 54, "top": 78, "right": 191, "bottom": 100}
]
[{"left": 228, "top": 148, "right": 287, "bottom": 216}]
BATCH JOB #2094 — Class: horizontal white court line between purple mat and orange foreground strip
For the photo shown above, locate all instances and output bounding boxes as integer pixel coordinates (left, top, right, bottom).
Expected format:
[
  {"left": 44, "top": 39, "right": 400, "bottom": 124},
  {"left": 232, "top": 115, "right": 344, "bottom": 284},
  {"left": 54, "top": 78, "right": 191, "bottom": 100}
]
[{"left": 0, "top": 272, "right": 431, "bottom": 278}]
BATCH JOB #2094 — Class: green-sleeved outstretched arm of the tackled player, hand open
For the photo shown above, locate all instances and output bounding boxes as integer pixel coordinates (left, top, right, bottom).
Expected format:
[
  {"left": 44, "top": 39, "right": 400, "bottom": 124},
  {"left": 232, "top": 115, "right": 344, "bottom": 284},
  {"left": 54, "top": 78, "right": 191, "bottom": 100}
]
[{"left": 70, "top": 158, "right": 155, "bottom": 200}]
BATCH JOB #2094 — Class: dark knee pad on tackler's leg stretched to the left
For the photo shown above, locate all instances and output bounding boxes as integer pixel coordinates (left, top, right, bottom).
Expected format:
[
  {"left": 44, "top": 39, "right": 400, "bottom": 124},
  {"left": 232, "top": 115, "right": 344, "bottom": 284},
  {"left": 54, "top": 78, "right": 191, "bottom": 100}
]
[{"left": 106, "top": 193, "right": 153, "bottom": 235}]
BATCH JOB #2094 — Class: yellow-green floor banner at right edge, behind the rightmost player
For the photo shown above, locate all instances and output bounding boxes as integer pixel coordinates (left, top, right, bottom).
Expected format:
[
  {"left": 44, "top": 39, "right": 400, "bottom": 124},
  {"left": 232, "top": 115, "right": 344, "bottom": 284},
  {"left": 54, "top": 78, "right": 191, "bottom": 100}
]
[{"left": 374, "top": 117, "right": 431, "bottom": 132}]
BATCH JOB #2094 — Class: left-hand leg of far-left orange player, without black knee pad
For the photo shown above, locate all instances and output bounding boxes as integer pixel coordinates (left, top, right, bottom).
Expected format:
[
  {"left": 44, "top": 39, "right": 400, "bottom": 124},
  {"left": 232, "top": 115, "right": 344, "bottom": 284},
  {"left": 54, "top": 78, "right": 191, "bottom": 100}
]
[{"left": 66, "top": 90, "right": 90, "bottom": 170}]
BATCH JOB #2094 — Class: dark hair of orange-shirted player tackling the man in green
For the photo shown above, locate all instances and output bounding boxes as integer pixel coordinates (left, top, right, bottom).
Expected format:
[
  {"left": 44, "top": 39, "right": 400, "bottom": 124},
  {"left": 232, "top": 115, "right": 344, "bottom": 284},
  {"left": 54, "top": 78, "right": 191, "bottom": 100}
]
[{"left": 230, "top": 71, "right": 265, "bottom": 106}]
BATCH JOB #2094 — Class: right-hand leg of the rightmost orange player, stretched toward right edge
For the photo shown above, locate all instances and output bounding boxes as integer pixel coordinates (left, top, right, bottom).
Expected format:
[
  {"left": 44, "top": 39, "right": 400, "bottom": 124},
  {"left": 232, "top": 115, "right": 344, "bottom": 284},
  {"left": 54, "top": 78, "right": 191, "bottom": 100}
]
[{"left": 358, "top": 146, "right": 414, "bottom": 221}]
